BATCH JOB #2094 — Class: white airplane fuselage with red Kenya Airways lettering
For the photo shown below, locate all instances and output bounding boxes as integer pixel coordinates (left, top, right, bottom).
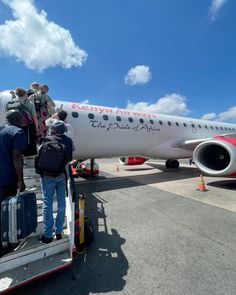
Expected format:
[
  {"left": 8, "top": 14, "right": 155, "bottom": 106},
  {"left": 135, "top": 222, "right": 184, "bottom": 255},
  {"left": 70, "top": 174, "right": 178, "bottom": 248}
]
[{"left": 0, "top": 92, "right": 236, "bottom": 159}]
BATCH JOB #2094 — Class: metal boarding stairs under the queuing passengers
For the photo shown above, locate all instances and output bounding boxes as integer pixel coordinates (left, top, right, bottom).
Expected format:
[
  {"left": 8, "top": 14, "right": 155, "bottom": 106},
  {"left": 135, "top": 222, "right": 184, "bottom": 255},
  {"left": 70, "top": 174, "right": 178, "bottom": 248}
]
[{"left": 0, "top": 158, "right": 74, "bottom": 294}]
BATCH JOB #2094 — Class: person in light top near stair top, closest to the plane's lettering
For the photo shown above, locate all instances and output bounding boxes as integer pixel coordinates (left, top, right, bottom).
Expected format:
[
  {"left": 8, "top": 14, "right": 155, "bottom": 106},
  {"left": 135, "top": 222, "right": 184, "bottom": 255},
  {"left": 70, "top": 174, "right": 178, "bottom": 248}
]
[{"left": 29, "top": 85, "right": 55, "bottom": 138}]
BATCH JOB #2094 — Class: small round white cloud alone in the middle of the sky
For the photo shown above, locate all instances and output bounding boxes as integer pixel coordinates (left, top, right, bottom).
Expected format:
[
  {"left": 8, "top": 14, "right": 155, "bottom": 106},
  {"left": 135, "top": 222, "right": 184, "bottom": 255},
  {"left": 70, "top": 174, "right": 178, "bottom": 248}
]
[{"left": 125, "top": 65, "right": 152, "bottom": 85}]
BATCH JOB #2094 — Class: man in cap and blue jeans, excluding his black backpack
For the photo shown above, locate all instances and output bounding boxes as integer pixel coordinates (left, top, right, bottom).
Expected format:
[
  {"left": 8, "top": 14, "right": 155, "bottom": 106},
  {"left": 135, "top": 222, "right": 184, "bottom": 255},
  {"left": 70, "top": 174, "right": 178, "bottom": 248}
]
[{"left": 40, "top": 122, "right": 73, "bottom": 243}]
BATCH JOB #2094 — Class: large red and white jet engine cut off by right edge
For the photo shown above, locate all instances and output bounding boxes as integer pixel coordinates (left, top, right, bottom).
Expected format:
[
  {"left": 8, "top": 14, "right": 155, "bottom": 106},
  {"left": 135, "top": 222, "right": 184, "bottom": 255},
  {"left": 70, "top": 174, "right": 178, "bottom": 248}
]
[{"left": 193, "top": 136, "right": 236, "bottom": 176}]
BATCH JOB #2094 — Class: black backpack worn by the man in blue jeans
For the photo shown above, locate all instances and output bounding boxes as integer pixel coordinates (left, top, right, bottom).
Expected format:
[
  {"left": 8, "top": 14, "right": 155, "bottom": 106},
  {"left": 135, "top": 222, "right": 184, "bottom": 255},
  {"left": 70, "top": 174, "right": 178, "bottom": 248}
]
[{"left": 34, "top": 141, "right": 66, "bottom": 177}]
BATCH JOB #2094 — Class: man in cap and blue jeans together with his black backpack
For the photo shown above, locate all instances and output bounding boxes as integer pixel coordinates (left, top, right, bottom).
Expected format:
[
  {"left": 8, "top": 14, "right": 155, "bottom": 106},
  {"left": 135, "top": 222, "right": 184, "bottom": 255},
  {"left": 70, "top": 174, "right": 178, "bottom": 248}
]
[{"left": 35, "top": 121, "right": 73, "bottom": 244}]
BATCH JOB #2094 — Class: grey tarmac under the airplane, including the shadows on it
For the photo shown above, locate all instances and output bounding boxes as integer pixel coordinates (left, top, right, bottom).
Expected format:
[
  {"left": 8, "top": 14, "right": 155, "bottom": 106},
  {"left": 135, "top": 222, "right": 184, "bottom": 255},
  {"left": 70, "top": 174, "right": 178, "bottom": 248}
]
[{"left": 12, "top": 159, "right": 236, "bottom": 295}]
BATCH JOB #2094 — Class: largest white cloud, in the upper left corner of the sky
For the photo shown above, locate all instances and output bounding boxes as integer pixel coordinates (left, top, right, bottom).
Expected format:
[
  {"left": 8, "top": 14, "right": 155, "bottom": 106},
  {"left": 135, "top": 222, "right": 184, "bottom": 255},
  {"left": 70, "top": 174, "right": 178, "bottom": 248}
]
[{"left": 0, "top": 0, "right": 87, "bottom": 71}]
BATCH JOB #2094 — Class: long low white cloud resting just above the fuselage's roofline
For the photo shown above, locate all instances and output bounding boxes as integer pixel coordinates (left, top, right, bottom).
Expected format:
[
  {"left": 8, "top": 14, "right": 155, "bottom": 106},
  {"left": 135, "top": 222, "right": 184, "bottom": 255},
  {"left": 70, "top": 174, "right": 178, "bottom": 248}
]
[{"left": 126, "top": 93, "right": 188, "bottom": 115}]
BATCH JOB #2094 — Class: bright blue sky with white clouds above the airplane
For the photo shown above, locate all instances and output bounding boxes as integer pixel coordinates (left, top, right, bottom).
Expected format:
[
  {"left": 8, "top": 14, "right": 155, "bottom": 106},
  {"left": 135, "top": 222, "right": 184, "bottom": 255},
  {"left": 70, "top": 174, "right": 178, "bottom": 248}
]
[{"left": 0, "top": 0, "right": 236, "bottom": 122}]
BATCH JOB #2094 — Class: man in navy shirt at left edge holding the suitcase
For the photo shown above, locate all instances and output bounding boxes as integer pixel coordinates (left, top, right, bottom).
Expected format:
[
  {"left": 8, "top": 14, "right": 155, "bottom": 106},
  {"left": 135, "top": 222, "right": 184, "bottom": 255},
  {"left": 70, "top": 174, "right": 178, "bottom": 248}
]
[{"left": 0, "top": 110, "right": 27, "bottom": 257}]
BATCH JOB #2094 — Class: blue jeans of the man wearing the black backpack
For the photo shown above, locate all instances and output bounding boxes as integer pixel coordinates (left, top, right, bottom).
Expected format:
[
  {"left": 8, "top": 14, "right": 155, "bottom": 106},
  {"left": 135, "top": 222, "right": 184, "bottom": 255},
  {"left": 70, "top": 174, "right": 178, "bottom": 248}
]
[{"left": 41, "top": 174, "right": 66, "bottom": 238}]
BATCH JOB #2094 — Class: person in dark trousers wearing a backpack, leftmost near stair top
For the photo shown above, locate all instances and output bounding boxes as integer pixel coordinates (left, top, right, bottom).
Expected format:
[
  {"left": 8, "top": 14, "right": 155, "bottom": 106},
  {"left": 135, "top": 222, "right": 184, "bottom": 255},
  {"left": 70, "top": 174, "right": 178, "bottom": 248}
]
[{"left": 15, "top": 88, "right": 39, "bottom": 156}]
